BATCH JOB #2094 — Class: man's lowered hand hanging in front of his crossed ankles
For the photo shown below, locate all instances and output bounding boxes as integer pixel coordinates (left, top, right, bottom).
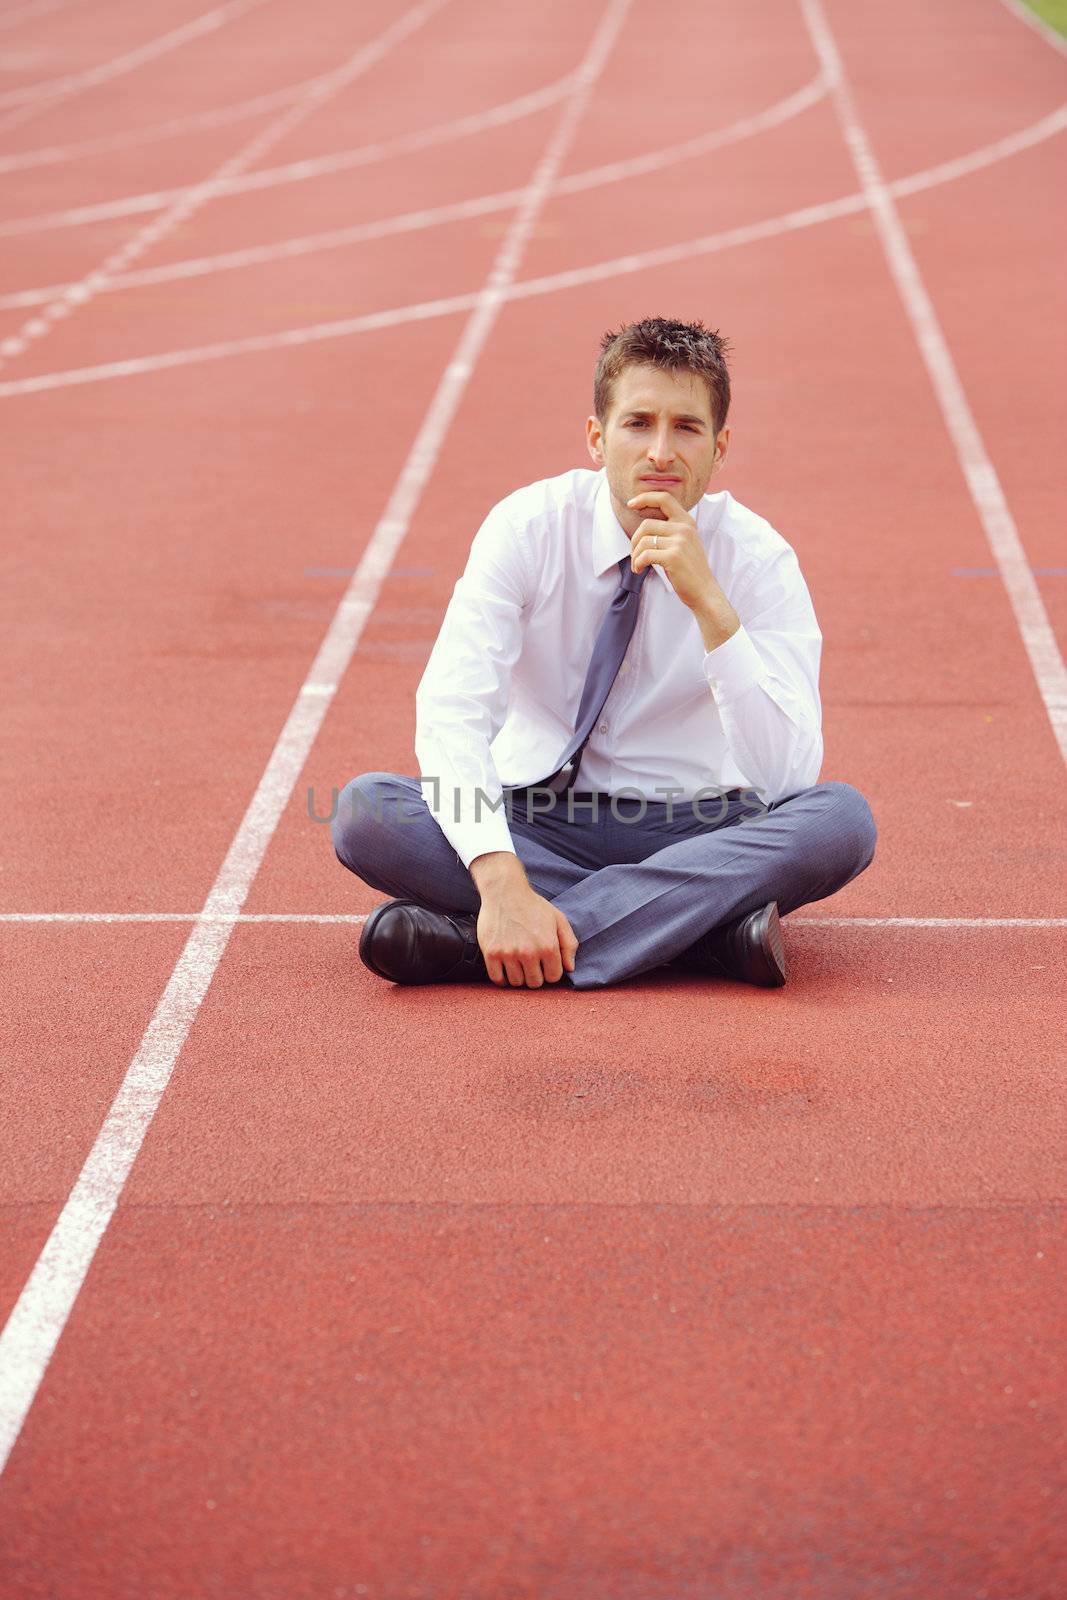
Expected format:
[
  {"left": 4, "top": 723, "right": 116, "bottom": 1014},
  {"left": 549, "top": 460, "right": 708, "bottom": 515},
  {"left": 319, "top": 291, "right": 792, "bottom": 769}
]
[{"left": 470, "top": 853, "right": 577, "bottom": 989}]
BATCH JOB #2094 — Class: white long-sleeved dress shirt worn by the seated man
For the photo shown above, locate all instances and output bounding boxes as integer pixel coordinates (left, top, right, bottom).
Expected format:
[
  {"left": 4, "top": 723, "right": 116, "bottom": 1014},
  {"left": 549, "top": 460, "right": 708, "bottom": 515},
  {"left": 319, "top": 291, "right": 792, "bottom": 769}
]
[{"left": 414, "top": 467, "right": 822, "bottom": 867}]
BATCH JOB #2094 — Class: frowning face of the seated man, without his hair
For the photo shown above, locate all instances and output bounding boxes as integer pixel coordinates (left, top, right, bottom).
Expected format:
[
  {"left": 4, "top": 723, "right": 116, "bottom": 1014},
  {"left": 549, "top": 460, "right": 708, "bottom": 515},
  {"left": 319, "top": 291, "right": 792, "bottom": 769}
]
[{"left": 585, "top": 366, "right": 729, "bottom": 534}]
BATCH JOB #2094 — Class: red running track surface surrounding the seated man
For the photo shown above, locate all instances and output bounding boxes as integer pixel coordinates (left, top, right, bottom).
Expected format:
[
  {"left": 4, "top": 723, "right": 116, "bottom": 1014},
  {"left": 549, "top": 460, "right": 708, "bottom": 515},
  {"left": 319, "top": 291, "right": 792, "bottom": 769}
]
[{"left": 0, "top": 0, "right": 1067, "bottom": 1600}]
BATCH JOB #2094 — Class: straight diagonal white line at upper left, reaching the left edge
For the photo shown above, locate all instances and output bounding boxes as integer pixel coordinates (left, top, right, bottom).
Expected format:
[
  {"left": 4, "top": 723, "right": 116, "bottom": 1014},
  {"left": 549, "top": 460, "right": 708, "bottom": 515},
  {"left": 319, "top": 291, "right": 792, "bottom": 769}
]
[{"left": 0, "top": 0, "right": 445, "bottom": 368}]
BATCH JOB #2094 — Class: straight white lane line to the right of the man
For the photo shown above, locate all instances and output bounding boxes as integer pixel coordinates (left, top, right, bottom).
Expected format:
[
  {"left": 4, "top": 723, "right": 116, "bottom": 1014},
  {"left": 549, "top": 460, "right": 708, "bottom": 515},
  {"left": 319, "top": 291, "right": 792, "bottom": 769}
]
[{"left": 800, "top": 0, "right": 1067, "bottom": 762}]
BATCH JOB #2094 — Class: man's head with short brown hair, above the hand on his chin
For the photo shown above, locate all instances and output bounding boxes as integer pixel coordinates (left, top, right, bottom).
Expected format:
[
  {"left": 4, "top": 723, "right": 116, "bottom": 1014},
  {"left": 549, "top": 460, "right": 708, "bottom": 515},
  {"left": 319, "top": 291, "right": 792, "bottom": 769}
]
[{"left": 585, "top": 317, "right": 729, "bottom": 534}]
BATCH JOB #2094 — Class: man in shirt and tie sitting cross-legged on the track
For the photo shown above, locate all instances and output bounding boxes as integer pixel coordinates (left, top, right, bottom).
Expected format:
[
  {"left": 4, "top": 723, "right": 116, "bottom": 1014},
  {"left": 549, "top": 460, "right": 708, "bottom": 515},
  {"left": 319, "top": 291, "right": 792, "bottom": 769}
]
[{"left": 333, "top": 317, "right": 877, "bottom": 989}]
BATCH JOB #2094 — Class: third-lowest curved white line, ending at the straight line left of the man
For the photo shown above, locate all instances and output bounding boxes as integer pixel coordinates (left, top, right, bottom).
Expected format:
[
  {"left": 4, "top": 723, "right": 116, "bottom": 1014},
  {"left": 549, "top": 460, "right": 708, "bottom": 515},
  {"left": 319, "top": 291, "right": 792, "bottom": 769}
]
[{"left": 0, "top": 74, "right": 574, "bottom": 238}]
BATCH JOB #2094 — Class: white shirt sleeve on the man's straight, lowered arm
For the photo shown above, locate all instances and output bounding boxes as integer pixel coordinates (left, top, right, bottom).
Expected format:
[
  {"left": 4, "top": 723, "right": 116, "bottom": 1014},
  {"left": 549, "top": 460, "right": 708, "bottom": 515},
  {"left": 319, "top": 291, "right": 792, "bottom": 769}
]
[{"left": 414, "top": 506, "right": 533, "bottom": 867}]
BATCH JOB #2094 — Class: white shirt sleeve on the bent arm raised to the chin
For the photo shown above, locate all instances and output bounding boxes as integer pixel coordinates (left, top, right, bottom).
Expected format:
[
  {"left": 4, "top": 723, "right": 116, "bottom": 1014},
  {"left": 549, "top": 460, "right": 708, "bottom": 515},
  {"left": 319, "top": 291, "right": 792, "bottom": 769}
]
[{"left": 704, "top": 547, "right": 822, "bottom": 803}]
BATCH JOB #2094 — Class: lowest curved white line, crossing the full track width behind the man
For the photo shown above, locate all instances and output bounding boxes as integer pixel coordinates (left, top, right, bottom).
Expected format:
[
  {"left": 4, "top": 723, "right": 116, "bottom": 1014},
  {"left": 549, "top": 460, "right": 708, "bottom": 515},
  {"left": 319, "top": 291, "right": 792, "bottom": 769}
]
[{"left": 0, "top": 106, "right": 1067, "bottom": 400}]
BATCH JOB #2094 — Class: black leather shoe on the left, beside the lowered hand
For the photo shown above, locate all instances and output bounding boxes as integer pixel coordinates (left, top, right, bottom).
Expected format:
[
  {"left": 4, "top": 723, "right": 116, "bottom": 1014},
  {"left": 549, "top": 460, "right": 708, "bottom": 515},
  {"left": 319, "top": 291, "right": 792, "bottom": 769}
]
[{"left": 360, "top": 901, "right": 490, "bottom": 984}]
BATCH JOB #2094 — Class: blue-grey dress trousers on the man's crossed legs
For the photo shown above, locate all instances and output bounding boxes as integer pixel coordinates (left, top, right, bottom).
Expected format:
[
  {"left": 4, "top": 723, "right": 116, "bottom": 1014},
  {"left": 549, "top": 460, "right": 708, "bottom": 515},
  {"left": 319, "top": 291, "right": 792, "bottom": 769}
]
[{"left": 331, "top": 773, "right": 877, "bottom": 989}]
